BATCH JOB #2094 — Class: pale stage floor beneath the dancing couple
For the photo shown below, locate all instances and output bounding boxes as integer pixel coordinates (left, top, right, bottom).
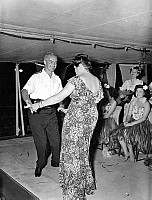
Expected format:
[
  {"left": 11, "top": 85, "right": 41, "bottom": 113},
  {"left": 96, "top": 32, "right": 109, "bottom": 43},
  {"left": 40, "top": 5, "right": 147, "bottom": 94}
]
[{"left": 0, "top": 136, "right": 152, "bottom": 200}]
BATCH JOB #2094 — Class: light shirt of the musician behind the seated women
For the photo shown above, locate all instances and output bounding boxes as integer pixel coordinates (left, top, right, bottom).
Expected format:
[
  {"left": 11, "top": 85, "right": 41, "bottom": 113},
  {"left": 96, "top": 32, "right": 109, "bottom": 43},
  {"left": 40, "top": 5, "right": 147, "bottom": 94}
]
[{"left": 120, "top": 79, "right": 143, "bottom": 91}]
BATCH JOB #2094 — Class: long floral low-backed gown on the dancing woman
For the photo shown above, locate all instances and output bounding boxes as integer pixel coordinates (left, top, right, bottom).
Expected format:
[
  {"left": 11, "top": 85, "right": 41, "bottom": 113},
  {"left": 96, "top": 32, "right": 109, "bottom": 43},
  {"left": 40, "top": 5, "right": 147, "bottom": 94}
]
[{"left": 59, "top": 76, "right": 103, "bottom": 200}]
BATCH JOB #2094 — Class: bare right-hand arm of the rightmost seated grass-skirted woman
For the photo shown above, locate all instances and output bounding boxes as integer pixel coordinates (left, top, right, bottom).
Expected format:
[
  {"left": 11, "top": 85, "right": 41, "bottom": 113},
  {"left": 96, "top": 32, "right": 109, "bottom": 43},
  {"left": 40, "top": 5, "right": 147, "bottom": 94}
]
[{"left": 126, "top": 101, "right": 150, "bottom": 126}]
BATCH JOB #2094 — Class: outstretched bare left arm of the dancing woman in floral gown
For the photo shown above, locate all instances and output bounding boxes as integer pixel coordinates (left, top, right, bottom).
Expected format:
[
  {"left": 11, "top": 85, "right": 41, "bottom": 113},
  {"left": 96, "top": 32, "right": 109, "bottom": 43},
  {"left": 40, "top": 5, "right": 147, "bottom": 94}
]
[{"left": 32, "top": 82, "right": 75, "bottom": 111}]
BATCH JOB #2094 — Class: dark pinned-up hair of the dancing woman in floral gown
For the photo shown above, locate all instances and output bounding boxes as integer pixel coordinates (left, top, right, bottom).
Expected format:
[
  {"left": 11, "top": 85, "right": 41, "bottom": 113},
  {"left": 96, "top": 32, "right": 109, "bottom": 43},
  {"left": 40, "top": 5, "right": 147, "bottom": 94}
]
[{"left": 72, "top": 54, "right": 92, "bottom": 69}]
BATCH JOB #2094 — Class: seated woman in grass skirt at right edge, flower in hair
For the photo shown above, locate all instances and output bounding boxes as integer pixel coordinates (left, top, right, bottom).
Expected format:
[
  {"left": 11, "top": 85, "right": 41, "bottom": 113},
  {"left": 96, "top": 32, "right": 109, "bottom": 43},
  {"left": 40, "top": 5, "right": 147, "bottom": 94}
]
[{"left": 110, "top": 85, "right": 151, "bottom": 161}]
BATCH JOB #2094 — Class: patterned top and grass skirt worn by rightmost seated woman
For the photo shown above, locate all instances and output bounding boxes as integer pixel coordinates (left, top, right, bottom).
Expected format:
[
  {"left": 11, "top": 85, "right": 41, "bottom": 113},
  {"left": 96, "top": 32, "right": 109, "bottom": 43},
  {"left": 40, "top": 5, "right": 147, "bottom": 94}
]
[{"left": 110, "top": 97, "right": 152, "bottom": 154}]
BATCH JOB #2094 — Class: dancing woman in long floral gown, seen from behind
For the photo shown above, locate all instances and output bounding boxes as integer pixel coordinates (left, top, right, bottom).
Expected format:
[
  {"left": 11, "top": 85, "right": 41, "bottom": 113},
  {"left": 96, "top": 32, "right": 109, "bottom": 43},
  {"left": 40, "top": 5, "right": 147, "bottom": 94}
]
[{"left": 29, "top": 55, "right": 103, "bottom": 200}]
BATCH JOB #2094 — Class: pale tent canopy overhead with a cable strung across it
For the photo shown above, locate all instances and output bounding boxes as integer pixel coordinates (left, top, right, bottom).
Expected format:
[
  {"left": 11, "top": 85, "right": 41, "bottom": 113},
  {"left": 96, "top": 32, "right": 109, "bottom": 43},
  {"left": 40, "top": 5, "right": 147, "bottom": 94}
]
[{"left": 0, "top": 0, "right": 152, "bottom": 63}]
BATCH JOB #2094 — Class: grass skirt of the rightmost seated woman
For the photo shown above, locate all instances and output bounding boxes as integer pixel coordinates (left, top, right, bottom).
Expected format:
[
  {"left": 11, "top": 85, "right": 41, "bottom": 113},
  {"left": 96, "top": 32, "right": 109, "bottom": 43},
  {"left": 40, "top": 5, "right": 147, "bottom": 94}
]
[{"left": 109, "top": 120, "right": 152, "bottom": 154}]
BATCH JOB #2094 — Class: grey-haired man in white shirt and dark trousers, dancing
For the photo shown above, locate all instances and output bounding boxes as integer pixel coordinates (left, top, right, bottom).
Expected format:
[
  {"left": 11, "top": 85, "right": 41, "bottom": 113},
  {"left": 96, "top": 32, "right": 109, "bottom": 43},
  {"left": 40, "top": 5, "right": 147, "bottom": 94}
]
[{"left": 22, "top": 53, "right": 62, "bottom": 177}]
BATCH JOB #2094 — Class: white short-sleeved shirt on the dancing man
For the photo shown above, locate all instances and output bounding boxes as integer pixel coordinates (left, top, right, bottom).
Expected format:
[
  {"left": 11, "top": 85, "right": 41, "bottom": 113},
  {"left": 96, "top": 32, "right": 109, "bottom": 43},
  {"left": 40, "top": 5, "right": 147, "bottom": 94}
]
[{"left": 23, "top": 69, "right": 63, "bottom": 100}]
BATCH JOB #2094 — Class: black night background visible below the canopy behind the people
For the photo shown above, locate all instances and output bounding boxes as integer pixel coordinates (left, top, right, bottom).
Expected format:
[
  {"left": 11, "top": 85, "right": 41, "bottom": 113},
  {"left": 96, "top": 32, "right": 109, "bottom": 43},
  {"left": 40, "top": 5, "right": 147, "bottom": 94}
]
[{"left": 0, "top": 62, "right": 152, "bottom": 139}]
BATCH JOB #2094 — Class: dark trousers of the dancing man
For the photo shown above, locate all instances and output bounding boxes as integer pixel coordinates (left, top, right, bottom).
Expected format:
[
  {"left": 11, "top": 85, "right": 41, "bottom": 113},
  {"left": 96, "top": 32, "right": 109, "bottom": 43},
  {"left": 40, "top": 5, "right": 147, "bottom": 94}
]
[{"left": 28, "top": 107, "right": 60, "bottom": 168}]
